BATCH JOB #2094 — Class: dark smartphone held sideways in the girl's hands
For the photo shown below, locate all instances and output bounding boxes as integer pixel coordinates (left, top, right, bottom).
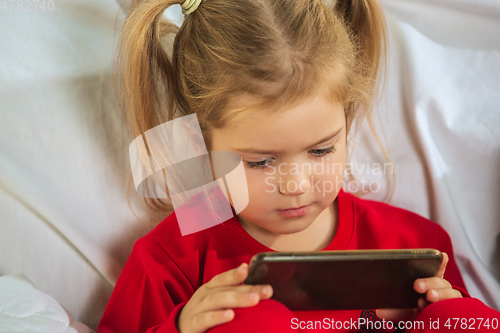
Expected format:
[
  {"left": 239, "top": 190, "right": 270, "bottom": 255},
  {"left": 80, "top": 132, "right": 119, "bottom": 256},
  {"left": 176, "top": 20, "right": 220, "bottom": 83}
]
[{"left": 244, "top": 249, "right": 443, "bottom": 311}]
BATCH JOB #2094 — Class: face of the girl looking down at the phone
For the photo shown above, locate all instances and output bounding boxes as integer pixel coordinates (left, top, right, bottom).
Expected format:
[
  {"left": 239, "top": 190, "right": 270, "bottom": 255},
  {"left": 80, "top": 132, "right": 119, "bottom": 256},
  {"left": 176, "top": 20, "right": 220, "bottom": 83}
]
[{"left": 212, "top": 94, "right": 346, "bottom": 235}]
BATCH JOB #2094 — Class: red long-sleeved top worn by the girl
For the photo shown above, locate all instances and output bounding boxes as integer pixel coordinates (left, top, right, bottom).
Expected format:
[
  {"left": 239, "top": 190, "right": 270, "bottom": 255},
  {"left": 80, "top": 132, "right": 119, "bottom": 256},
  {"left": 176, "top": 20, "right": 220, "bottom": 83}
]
[{"left": 98, "top": 190, "right": 494, "bottom": 333}]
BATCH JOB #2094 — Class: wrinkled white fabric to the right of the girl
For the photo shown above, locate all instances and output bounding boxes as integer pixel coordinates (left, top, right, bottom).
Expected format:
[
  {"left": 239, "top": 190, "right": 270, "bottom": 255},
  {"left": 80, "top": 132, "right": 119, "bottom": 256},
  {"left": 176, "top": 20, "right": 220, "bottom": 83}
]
[{"left": 352, "top": 0, "right": 500, "bottom": 309}]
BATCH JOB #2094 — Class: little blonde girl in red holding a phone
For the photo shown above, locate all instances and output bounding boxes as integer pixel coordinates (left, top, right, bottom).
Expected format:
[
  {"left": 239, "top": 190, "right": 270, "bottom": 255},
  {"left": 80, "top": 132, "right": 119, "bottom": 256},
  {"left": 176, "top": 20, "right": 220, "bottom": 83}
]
[{"left": 98, "top": 0, "right": 498, "bottom": 333}]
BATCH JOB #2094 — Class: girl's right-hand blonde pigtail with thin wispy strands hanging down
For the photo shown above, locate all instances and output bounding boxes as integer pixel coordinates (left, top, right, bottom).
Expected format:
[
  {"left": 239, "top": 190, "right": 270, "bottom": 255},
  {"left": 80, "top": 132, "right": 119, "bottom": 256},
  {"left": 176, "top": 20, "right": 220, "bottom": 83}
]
[{"left": 334, "top": 0, "right": 396, "bottom": 202}]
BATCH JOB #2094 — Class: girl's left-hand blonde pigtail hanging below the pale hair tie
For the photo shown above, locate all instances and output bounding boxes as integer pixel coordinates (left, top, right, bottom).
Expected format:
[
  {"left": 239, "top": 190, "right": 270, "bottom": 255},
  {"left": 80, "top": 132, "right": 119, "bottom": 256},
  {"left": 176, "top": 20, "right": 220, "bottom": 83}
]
[{"left": 114, "top": 0, "right": 182, "bottom": 211}]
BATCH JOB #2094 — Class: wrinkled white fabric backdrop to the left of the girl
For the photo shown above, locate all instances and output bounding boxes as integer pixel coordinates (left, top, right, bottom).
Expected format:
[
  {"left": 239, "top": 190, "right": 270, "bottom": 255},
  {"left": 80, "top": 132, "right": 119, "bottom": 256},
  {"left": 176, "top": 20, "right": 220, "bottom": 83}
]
[{"left": 0, "top": 0, "right": 168, "bottom": 329}]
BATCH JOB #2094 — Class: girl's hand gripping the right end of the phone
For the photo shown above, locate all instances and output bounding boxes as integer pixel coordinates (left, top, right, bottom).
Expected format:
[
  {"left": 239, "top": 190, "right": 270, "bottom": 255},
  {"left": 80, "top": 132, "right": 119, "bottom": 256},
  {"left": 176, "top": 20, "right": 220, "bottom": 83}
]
[{"left": 376, "top": 252, "right": 462, "bottom": 322}]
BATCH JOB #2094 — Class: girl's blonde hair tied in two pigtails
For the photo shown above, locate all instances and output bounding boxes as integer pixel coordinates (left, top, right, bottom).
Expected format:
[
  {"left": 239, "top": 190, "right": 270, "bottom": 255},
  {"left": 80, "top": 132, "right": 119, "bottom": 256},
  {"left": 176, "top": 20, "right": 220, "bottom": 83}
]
[{"left": 115, "top": 0, "right": 387, "bottom": 210}]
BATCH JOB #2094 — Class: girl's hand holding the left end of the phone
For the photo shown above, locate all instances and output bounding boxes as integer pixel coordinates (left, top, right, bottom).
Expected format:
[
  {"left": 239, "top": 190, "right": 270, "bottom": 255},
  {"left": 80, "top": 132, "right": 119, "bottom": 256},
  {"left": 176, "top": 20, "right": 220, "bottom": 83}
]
[{"left": 177, "top": 263, "right": 273, "bottom": 333}]
